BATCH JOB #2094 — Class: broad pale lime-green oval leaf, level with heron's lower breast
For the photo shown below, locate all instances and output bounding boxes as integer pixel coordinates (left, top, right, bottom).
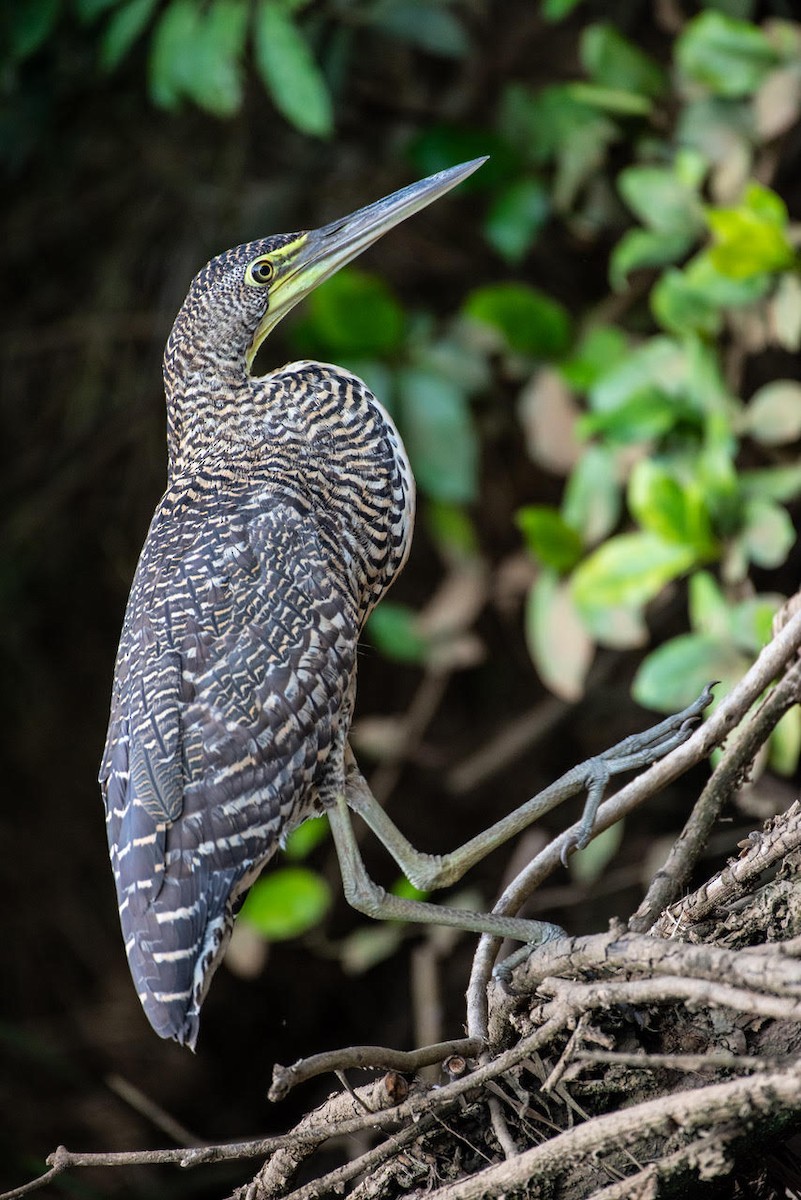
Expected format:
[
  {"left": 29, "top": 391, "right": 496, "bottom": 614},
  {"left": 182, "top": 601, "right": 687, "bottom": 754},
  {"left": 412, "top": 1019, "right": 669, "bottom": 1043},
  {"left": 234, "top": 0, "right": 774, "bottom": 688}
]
[{"left": 572, "top": 532, "right": 697, "bottom": 611}]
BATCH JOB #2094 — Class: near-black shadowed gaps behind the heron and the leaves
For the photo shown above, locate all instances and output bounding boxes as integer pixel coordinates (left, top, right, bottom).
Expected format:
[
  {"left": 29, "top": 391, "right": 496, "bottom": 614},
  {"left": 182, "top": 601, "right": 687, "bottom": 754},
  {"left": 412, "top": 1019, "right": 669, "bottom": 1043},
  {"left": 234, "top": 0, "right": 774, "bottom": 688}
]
[{"left": 0, "top": 0, "right": 799, "bottom": 1198}]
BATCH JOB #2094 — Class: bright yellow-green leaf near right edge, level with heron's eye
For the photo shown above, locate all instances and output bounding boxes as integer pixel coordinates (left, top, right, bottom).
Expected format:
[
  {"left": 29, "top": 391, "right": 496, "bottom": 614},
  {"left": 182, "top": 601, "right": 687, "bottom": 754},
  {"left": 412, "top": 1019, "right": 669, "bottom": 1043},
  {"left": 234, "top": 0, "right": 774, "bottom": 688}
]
[{"left": 706, "top": 182, "right": 796, "bottom": 280}]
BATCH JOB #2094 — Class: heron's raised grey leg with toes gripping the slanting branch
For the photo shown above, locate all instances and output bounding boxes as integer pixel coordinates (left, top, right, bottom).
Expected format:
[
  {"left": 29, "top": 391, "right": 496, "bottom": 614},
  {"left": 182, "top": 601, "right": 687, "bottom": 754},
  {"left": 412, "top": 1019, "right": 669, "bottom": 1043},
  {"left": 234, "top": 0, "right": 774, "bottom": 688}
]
[{"left": 345, "top": 684, "right": 712, "bottom": 902}]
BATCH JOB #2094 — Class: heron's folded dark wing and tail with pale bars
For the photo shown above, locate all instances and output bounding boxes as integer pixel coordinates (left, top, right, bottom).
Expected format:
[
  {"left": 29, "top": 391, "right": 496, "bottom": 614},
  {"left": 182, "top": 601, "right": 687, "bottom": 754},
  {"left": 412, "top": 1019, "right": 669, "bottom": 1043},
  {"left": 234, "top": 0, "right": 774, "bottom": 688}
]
[{"left": 101, "top": 485, "right": 357, "bottom": 1045}]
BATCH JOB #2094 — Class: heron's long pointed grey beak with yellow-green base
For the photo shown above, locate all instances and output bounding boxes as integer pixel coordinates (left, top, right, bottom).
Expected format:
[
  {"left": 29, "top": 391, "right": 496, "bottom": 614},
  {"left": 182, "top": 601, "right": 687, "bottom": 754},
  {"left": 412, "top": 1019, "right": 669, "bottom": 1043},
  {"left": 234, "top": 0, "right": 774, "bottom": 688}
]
[{"left": 248, "top": 157, "right": 487, "bottom": 366}]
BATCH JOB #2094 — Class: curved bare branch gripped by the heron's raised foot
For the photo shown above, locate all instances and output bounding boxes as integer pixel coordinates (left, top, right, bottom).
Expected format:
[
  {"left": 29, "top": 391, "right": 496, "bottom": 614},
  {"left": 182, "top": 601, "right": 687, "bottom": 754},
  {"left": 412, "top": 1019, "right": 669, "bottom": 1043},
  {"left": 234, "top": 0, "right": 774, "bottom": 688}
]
[{"left": 466, "top": 612, "right": 801, "bottom": 1040}]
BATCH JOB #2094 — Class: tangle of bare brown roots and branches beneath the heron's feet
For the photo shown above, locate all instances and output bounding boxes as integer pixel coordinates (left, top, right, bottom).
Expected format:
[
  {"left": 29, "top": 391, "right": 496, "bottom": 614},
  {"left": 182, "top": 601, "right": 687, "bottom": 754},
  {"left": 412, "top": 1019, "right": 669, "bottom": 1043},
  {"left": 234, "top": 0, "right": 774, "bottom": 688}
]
[{"left": 6, "top": 613, "right": 801, "bottom": 1200}]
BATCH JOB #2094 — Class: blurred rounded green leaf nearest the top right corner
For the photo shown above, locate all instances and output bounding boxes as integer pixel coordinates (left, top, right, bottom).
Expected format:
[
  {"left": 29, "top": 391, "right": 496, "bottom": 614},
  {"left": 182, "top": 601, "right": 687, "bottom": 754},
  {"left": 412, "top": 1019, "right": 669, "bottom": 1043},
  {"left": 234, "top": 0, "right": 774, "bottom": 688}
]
[{"left": 675, "top": 12, "right": 777, "bottom": 97}]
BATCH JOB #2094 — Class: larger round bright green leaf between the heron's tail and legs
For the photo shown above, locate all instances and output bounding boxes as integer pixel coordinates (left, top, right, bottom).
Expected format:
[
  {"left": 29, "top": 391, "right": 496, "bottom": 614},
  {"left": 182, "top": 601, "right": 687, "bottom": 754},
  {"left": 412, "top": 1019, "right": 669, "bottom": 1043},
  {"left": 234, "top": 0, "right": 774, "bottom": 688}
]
[{"left": 239, "top": 866, "right": 331, "bottom": 942}]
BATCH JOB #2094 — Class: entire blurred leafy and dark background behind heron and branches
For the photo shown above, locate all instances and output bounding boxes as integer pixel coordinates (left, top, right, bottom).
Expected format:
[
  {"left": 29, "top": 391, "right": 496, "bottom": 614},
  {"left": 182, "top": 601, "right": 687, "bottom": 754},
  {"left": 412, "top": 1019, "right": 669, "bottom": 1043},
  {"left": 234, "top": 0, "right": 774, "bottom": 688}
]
[{"left": 0, "top": 0, "right": 801, "bottom": 1198}]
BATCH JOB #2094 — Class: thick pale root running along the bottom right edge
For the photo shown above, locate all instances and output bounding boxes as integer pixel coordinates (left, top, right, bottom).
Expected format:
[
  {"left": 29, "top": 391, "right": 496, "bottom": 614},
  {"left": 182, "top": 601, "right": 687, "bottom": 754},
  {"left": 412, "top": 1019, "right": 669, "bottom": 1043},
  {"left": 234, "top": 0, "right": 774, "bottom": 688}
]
[{"left": 417, "top": 1070, "right": 801, "bottom": 1200}]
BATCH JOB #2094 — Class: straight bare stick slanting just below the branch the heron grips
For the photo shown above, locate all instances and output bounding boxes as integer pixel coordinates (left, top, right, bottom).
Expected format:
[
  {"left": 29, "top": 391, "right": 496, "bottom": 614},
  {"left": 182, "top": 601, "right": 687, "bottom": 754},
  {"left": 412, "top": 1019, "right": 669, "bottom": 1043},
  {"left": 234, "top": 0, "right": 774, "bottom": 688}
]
[{"left": 630, "top": 664, "right": 801, "bottom": 932}]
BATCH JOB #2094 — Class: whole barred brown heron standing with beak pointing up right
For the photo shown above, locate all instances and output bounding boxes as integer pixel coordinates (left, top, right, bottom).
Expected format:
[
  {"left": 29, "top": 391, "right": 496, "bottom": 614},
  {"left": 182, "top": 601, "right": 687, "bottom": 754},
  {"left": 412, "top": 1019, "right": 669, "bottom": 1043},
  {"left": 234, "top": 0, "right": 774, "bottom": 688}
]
[{"left": 100, "top": 158, "right": 703, "bottom": 1046}]
